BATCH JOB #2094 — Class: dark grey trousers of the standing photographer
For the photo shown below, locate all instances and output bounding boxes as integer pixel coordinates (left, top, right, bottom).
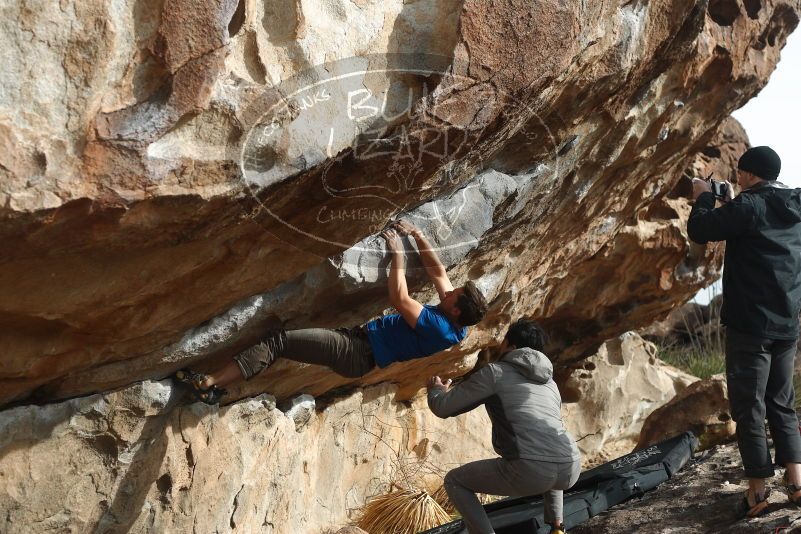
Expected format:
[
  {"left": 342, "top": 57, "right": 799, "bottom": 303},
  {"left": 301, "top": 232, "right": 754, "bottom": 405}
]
[{"left": 726, "top": 328, "right": 801, "bottom": 478}]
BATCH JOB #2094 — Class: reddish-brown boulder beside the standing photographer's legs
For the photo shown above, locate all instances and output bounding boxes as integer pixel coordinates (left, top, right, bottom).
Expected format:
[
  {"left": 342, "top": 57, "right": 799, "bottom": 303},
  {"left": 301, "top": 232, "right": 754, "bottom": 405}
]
[{"left": 637, "top": 374, "right": 736, "bottom": 450}]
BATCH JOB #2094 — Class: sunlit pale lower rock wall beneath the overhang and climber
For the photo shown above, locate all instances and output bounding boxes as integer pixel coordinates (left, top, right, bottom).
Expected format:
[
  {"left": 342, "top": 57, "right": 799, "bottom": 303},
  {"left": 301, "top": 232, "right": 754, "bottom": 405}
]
[{"left": 0, "top": 381, "right": 493, "bottom": 534}]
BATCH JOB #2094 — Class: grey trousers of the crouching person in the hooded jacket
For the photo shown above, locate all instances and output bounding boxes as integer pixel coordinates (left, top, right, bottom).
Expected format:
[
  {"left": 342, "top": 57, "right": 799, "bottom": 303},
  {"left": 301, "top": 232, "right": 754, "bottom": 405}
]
[{"left": 445, "top": 458, "right": 581, "bottom": 534}]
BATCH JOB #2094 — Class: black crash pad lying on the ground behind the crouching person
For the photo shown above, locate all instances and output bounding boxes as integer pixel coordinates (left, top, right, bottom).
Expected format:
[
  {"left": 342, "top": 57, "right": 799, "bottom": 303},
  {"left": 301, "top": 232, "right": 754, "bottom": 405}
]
[{"left": 422, "top": 432, "right": 698, "bottom": 534}]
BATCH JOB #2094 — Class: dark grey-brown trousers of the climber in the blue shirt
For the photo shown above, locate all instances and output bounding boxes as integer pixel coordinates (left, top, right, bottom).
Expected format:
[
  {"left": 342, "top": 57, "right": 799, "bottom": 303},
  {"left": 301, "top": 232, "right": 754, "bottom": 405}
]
[{"left": 234, "top": 326, "right": 375, "bottom": 380}]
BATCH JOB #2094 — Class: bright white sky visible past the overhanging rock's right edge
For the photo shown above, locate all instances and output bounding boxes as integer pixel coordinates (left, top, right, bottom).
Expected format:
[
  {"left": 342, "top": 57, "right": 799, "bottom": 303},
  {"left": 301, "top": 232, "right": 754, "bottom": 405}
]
[{"left": 693, "top": 28, "right": 801, "bottom": 304}]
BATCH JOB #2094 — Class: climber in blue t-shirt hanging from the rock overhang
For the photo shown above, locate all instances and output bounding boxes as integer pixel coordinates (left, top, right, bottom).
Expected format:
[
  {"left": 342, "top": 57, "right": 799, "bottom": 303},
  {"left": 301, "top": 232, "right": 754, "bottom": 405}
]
[{"left": 175, "top": 221, "right": 487, "bottom": 404}]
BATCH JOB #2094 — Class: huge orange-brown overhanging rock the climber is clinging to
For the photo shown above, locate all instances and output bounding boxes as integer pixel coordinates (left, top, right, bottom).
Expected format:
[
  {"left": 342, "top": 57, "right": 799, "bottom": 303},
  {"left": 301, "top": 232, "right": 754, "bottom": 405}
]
[{"left": 0, "top": 0, "right": 799, "bottom": 404}]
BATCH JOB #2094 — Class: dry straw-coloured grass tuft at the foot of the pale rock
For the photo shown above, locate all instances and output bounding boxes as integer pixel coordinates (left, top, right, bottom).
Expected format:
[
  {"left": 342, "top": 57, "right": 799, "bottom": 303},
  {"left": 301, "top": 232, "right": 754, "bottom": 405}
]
[{"left": 357, "top": 490, "right": 451, "bottom": 534}]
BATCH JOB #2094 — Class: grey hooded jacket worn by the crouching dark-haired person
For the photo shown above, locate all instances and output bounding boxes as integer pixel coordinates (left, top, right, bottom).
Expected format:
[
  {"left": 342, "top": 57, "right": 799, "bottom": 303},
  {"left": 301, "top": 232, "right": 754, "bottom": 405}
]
[{"left": 428, "top": 348, "right": 580, "bottom": 463}]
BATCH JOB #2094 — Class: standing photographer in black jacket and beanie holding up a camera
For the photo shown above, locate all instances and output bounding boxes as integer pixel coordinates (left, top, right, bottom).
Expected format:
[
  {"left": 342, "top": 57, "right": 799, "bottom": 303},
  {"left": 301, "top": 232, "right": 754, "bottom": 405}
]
[{"left": 687, "top": 146, "right": 801, "bottom": 517}]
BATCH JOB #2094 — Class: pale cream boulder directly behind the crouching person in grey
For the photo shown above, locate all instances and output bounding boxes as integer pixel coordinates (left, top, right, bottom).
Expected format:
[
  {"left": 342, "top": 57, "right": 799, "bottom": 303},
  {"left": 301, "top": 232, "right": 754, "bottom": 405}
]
[{"left": 560, "top": 332, "right": 698, "bottom": 465}]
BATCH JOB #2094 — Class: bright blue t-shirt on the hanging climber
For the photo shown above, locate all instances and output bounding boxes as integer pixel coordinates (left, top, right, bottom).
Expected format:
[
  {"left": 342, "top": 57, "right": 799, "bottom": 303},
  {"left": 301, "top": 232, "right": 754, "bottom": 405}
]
[{"left": 367, "top": 304, "right": 467, "bottom": 367}]
